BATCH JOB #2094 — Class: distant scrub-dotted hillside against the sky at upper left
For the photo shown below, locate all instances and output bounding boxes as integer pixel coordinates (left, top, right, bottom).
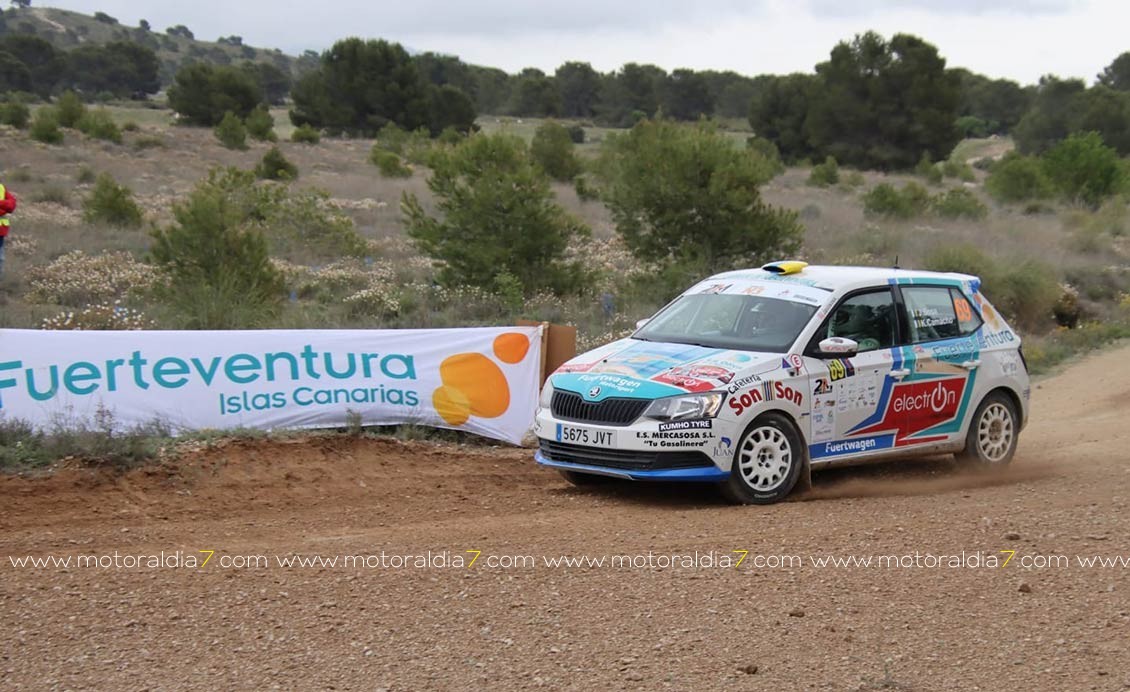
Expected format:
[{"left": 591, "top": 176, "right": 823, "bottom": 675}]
[{"left": 0, "top": 7, "right": 316, "bottom": 85}]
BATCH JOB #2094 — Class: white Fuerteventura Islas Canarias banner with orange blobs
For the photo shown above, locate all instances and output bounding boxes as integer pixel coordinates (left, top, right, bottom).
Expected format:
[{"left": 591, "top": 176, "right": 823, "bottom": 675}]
[{"left": 0, "top": 327, "right": 541, "bottom": 443}]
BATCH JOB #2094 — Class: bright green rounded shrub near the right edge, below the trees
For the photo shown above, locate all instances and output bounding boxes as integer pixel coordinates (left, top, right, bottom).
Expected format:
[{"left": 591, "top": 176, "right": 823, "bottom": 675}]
[{"left": 1041, "top": 132, "right": 1123, "bottom": 207}]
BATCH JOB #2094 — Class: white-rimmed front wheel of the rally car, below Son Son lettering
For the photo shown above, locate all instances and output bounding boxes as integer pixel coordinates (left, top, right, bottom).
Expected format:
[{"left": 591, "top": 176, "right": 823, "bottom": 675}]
[{"left": 719, "top": 413, "right": 806, "bottom": 504}]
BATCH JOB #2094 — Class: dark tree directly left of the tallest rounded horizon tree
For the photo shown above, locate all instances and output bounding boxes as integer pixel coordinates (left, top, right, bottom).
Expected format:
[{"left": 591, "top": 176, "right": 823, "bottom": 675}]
[{"left": 749, "top": 73, "right": 817, "bottom": 162}]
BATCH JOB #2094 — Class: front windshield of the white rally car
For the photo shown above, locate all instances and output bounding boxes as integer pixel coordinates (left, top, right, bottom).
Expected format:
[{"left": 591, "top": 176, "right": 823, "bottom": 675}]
[{"left": 633, "top": 294, "right": 816, "bottom": 353}]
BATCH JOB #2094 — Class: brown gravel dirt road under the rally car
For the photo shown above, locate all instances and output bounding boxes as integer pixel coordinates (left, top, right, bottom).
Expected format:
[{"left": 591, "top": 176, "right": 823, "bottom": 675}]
[{"left": 0, "top": 351, "right": 1130, "bottom": 690}]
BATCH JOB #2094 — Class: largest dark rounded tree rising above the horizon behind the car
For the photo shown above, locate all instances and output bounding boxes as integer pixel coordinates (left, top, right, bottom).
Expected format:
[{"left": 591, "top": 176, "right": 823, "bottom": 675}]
[{"left": 805, "top": 32, "right": 959, "bottom": 170}]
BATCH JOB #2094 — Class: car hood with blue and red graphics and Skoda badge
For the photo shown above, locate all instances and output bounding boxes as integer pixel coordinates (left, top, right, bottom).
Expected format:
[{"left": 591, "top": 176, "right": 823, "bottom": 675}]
[{"left": 550, "top": 338, "right": 789, "bottom": 401}]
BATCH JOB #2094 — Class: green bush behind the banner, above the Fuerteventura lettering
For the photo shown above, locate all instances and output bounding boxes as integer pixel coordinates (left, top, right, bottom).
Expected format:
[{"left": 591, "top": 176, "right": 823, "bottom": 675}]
[{"left": 150, "top": 168, "right": 284, "bottom": 329}]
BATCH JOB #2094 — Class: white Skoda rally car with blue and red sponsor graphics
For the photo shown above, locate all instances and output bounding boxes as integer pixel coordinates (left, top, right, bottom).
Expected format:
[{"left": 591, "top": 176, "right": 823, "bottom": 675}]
[{"left": 534, "top": 262, "right": 1029, "bottom": 503}]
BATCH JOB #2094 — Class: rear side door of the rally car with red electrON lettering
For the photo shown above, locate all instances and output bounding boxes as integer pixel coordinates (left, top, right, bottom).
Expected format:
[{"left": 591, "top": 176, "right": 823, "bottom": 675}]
[{"left": 889, "top": 284, "right": 981, "bottom": 448}]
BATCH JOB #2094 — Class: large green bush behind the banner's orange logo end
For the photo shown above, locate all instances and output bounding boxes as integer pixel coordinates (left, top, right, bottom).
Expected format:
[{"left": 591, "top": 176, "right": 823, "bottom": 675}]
[{"left": 401, "top": 133, "right": 590, "bottom": 294}]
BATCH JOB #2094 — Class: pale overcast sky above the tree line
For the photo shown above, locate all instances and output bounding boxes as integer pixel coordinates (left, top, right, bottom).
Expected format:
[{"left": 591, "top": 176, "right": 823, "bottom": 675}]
[{"left": 33, "top": 0, "right": 1130, "bottom": 83}]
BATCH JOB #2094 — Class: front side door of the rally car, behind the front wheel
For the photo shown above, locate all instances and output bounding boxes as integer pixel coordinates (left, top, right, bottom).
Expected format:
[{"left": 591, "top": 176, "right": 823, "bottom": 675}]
[{"left": 806, "top": 286, "right": 911, "bottom": 464}]
